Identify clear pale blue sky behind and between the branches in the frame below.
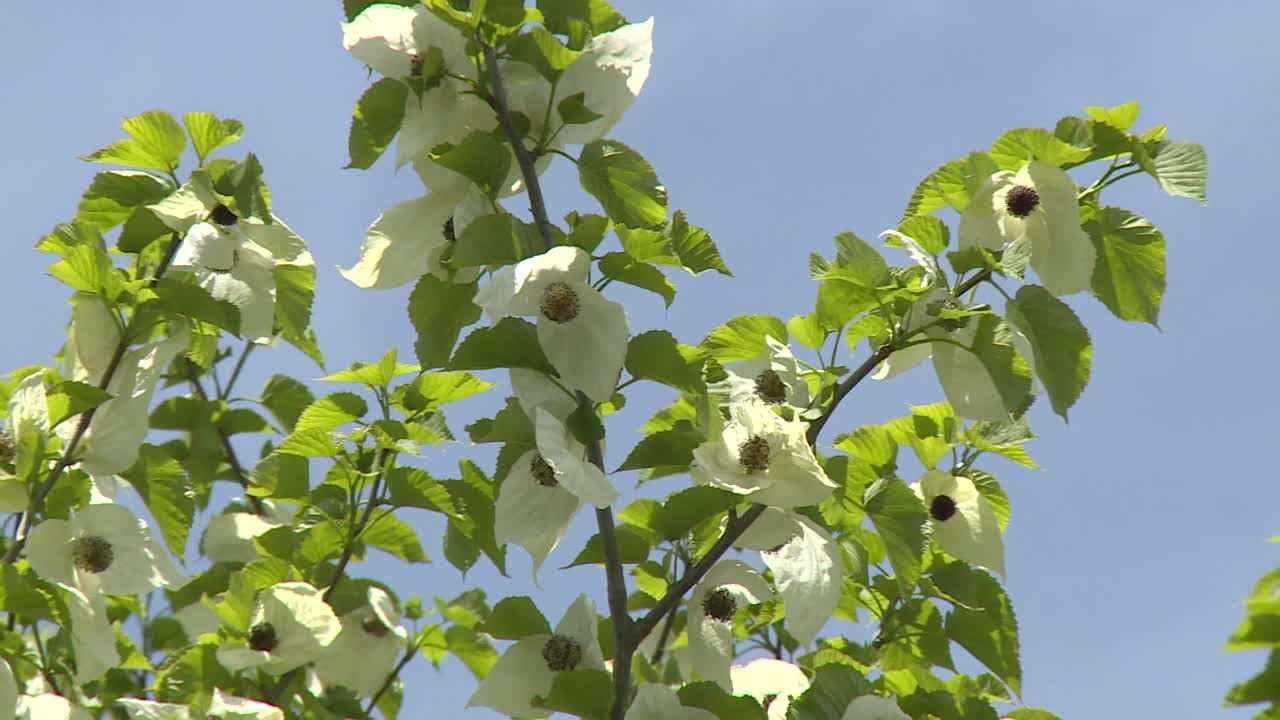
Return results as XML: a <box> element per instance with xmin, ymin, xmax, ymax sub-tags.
<box><xmin>0</xmin><ymin>0</ymin><xmax>1280</xmax><ymax>720</ymax></box>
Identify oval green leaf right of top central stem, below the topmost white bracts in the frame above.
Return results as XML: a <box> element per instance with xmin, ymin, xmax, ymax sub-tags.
<box><xmin>577</xmin><ymin>140</ymin><xmax>667</xmax><ymax>228</ymax></box>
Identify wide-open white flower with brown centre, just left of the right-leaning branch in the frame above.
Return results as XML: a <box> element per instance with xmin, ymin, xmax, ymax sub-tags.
<box><xmin>690</xmin><ymin>397</ymin><xmax>836</xmax><ymax>507</ymax></box>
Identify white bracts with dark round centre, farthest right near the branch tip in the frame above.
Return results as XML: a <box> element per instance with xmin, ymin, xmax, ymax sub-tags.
<box><xmin>960</xmin><ymin>160</ymin><xmax>1096</xmax><ymax>295</ymax></box>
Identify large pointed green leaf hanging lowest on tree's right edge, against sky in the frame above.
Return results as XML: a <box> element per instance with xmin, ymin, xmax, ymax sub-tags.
<box><xmin>929</xmin><ymin>561</ymin><xmax>1023</xmax><ymax>693</ymax></box>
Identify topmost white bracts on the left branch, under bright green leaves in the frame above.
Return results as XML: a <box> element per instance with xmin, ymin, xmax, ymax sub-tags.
<box><xmin>148</xmin><ymin>174</ymin><xmax>315</xmax><ymax>343</ymax></box>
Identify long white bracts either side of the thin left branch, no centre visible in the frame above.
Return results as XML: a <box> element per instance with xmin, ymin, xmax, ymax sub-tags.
<box><xmin>56</xmin><ymin>293</ymin><xmax>188</xmax><ymax>478</ymax></box>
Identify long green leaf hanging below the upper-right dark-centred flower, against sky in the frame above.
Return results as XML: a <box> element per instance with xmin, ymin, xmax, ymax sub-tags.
<box><xmin>1005</xmin><ymin>284</ymin><xmax>1093</xmax><ymax>420</ymax></box>
